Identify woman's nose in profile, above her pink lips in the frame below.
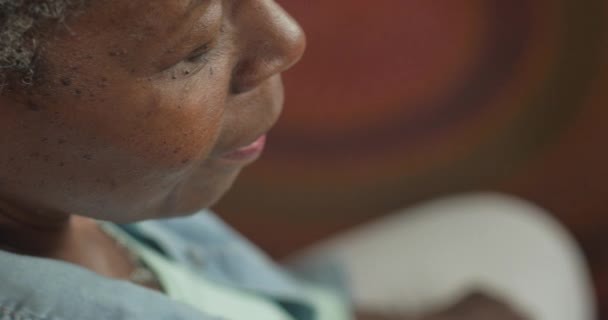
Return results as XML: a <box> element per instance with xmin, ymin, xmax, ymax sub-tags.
<box><xmin>232</xmin><ymin>0</ymin><xmax>306</xmax><ymax>94</ymax></box>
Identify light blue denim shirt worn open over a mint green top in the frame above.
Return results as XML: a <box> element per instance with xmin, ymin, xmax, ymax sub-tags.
<box><xmin>0</xmin><ymin>211</ymin><xmax>350</xmax><ymax>320</ymax></box>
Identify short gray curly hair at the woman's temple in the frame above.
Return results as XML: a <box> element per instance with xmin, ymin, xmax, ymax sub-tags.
<box><xmin>0</xmin><ymin>0</ymin><xmax>85</xmax><ymax>86</ymax></box>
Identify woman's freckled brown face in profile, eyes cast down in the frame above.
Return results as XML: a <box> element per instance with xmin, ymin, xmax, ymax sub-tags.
<box><xmin>0</xmin><ymin>0</ymin><xmax>305</xmax><ymax>222</ymax></box>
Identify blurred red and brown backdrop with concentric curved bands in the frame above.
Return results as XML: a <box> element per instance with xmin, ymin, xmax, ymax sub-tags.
<box><xmin>216</xmin><ymin>0</ymin><xmax>608</xmax><ymax>319</ymax></box>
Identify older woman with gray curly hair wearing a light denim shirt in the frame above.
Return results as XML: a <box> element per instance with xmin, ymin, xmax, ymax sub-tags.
<box><xmin>0</xmin><ymin>0</ymin><xmax>596</xmax><ymax>320</ymax></box>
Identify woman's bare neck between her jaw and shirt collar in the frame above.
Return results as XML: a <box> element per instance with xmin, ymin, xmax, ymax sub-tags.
<box><xmin>0</xmin><ymin>200</ymin><xmax>142</xmax><ymax>279</ymax></box>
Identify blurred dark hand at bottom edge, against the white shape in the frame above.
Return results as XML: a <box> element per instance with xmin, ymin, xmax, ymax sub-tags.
<box><xmin>357</xmin><ymin>293</ymin><xmax>532</xmax><ymax>320</ymax></box>
